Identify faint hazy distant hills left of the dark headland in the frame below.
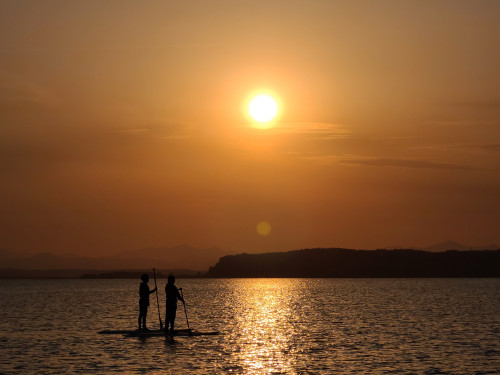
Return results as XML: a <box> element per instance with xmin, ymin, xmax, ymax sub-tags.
<box><xmin>0</xmin><ymin>245</ymin><xmax>234</xmax><ymax>271</ymax></box>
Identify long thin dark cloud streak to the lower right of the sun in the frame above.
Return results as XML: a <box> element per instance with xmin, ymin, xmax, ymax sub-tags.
<box><xmin>306</xmin><ymin>155</ymin><xmax>485</xmax><ymax>171</ymax></box>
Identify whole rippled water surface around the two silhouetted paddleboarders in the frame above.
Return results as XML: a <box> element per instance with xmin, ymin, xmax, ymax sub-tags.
<box><xmin>0</xmin><ymin>279</ymin><xmax>500</xmax><ymax>374</ymax></box>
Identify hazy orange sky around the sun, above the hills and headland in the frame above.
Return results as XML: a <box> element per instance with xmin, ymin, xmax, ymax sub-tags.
<box><xmin>0</xmin><ymin>0</ymin><xmax>500</xmax><ymax>254</ymax></box>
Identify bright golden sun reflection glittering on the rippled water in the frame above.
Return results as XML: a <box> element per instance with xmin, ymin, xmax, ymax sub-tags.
<box><xmin>228</xmin><ymin>279</ymin><xmax>308</xmax><ymax>373</ymax></box>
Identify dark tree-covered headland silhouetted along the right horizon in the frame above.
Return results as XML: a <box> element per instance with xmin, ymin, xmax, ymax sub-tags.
<box><xmin>207</xmin><ymin>249</ymin><xmax>500</xmax><ymax>277</ymax></box>
